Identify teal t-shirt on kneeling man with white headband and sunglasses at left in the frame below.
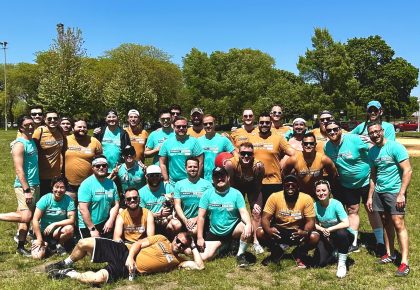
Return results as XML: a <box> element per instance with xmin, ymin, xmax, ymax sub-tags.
<box><xmin>77</xmin><ymin>175</ymin><xmax>120</xmax><ymax>228</ymax></box>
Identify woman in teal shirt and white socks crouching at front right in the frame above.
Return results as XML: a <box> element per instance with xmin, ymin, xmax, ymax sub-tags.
<box><xmin>314</xmin><ymin>180</ymin><xmax>354</xmax><ymax>278</ymax></box>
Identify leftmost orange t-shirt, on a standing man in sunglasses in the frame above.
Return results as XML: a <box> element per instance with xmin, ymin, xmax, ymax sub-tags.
<box><xmin>32</xmin><ymin>126</ymin><xmax>64</xmax><ymax>179</ymax></box>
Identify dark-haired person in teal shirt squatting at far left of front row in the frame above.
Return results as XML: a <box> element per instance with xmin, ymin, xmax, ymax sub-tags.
<box><xmin>32</xmin><ymin>177</ymin><xmax>76</xmax><ymax>259</ymax></box>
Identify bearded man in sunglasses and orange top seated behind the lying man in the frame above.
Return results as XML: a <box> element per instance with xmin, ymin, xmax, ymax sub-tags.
<box><xmin>113</xmin><ymin>188</ymin><xmax>155</xmax><ymax>244</ymax></box>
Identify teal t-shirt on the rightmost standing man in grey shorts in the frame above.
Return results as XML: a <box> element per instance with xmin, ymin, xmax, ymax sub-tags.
<box><xmin>368</xmin><ymin>140</ymin><xmax>408</xmax><ymax>194</ymax></box>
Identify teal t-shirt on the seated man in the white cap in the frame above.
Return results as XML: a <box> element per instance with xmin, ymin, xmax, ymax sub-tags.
<box><xmin>139</xmin><ymin>182</ymin><xmax>173</xmax><ymax>213</ymax></box>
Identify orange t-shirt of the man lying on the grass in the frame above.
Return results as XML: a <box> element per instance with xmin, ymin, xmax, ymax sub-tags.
<box><xmin>136</xmin><ymin>235</ymin><xmax>183</xmax><ymax>273</ymax></box>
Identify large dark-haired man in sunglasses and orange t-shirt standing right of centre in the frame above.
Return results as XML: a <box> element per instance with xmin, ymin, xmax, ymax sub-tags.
<box><xmin>249</xmin><ymin>114</ymin><xmax>295</xmax><ymax>206</ymax></box>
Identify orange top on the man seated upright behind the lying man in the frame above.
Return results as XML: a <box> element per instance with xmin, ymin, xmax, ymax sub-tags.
<box><xmin>120</xmin><ymin>208</ymin><xmax>149</xmax><ymax>243</ymax></box>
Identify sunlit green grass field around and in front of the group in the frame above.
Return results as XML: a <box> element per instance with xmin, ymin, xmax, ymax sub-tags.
<box><xmin>0</xmin><ymin>131</ymin><xmax>420</xmax><ymax>290</ymax></box>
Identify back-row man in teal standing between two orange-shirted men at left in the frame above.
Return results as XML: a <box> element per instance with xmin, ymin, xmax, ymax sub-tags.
<box><xmin>93</xmin><ymin>110</ymin><xmax>131</xmax><ymax>173</ymax></box>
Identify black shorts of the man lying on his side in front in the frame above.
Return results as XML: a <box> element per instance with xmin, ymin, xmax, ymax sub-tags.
<box><xmin>92</xmin><ymin>238</ymin><xmax>129</xmax><ymax>283</ymax></box>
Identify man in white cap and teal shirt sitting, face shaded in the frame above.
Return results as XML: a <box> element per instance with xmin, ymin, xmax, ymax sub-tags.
<box><xmin>140</xmin><ymin>165</ymin><xmax>182</xmax><ymax>236</ymax></box>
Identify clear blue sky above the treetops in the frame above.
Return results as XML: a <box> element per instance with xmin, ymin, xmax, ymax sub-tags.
<box><xmin>0</xmin><ymin>0</ymin><xmax>420</xmax><ymax>96</ymax></box>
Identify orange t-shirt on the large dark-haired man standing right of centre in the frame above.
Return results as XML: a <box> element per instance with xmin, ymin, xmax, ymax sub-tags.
<box><xmin>249</xmin><ymin>133</ymin><xmax>290</xmax><ymax>184</ymax></box>
